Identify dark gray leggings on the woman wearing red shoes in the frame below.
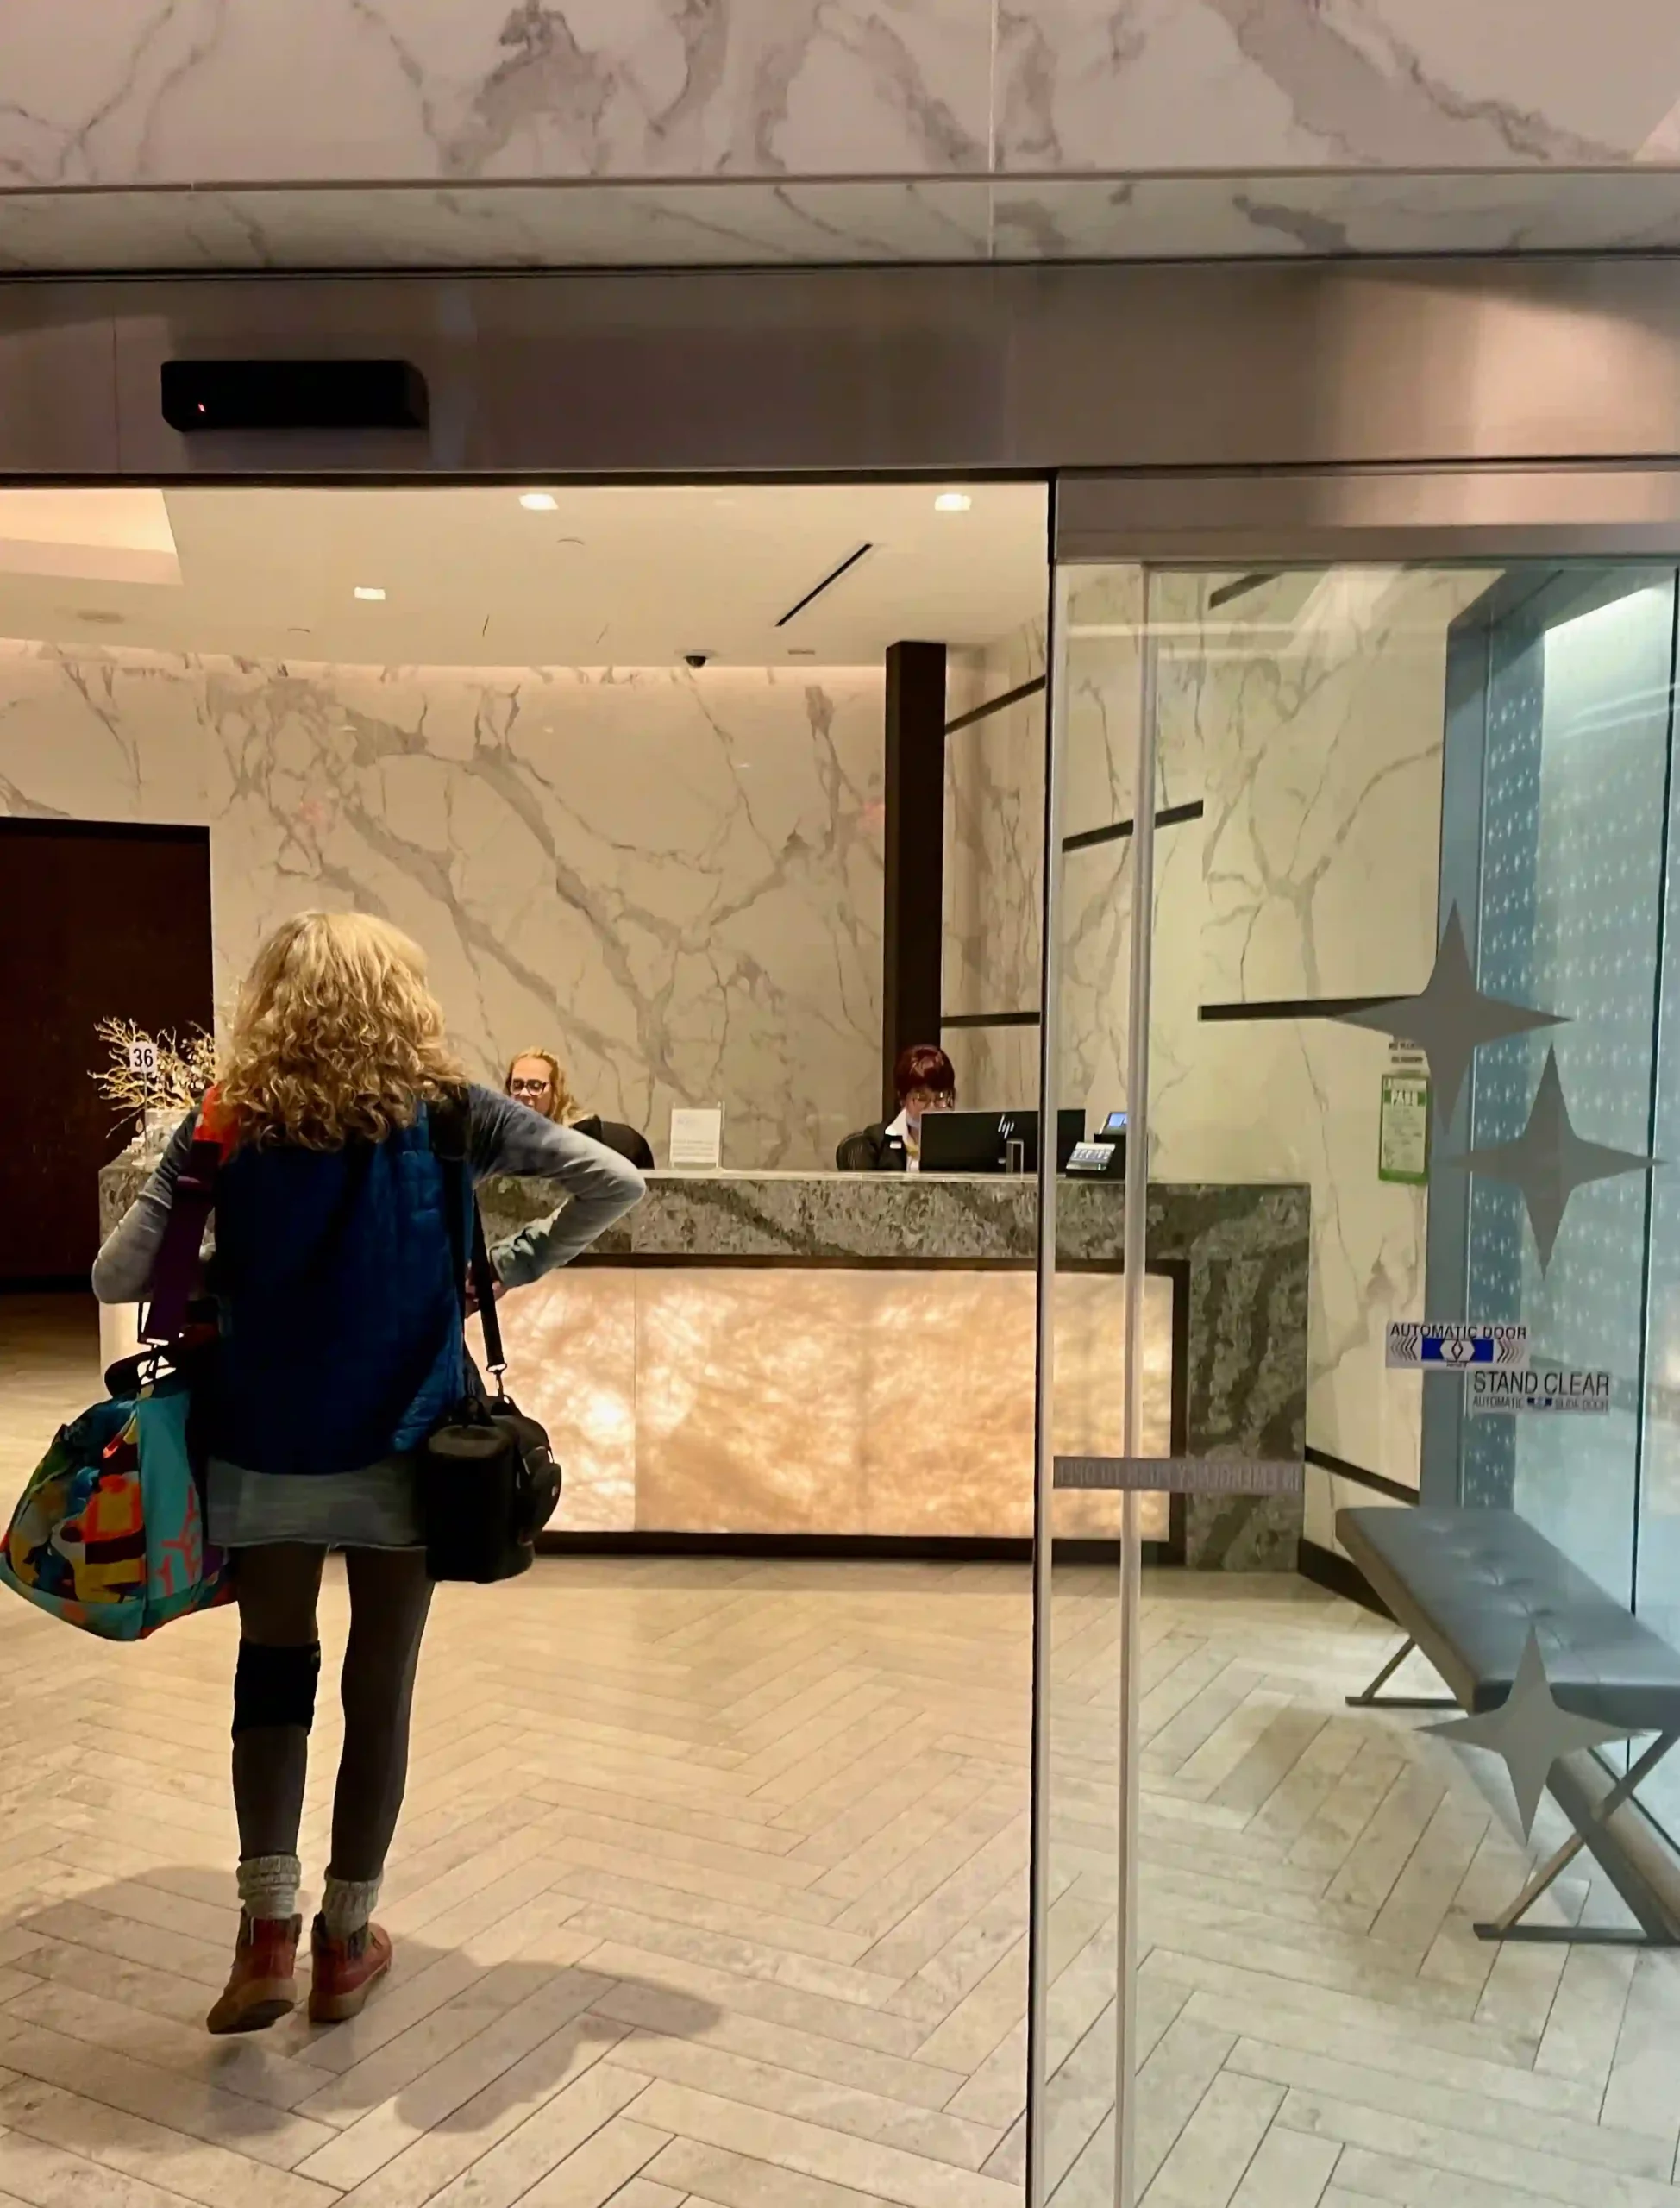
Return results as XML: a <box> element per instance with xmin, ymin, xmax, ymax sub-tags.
<box><xmin>234</xmin><ymin>1541</ymin><xmax>433</xmax><ymax>1879</ymax></box>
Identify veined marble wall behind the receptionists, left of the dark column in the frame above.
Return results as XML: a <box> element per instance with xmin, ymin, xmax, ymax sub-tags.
<box><xmin>0</xmin><ymin>645</ymin><xmax>881</xmax><ymax>1166</ymax></box>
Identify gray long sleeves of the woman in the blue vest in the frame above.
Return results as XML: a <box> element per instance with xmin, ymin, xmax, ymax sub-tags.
<box><xmin>93</xmin><ymin>1084</ymin><xmax>647</xmax><ymax>1302</ymax></box>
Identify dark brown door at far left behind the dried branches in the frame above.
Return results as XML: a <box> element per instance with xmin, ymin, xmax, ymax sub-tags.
<box><xmin>0</xmin><ymin>819</ymin><xmax>212</xmax><ymax>1289</ymax></box>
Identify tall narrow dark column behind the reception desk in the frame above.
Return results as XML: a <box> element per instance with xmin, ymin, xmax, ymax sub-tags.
<box><xmin>881</xmin><ymin>643</ymin><xmax>945</xmax><ymax>1117</ymax></box>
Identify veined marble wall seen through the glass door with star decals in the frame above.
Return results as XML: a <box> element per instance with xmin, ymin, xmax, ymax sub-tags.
<box><xmin>1155</xmin><ymin>569</ymin><xmax>1488</xmax><ymax>1486</ymax></box>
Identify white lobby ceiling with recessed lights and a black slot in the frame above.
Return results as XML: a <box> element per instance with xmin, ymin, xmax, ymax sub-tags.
<box><xmin>0</xmin><ymin>484</ymin><xmax>1046</xmax><ymax>667</ymax></box>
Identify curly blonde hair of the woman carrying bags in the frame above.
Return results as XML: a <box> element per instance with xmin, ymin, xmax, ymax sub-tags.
<box><xmin>218</xmin><ymin>912</ymin><xmax>466</xmax><ymax>1151</ymax></box>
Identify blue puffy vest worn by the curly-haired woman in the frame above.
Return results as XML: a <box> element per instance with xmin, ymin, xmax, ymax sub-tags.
<box><xmin>204</xmin><ymin>1111</ymin><xmax>468</xmax><ymax>1473</ymax></box>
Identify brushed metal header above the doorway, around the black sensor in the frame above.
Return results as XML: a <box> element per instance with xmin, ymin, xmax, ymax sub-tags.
<box><xmin>13</xmin><ymin>254</ymin><xmax>1680</xmax><ymax>483</ymax></box>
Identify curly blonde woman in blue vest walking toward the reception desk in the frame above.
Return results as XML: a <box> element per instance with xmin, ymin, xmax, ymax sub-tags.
<box><xmin>93</xmin><ymin>912</ymin><xmax>643</xmax><ymax>2031</ymax></box>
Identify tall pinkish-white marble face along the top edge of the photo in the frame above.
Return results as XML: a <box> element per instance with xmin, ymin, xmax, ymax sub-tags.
<box><xmin>0</xmin><ymin>0</ymin><xmax>1680</xmax><ymax>188</ymax></box>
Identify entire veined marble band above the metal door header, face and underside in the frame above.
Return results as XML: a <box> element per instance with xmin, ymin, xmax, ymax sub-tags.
<box><xmin>0</xmin><ymin>0</ymin><xmax>1680</xmax><ymax>242</ymax></box>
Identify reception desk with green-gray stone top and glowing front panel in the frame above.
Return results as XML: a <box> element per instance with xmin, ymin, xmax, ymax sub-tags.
<box><xmin>99</xmin><ymin>1152</ymin><xmax>1309</xmax><ymax>1570</ymax></box>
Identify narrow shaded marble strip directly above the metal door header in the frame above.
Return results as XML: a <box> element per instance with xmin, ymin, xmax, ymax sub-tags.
<box><xmin>16</xmin><ymin>168</ymin><xmax>1680</xmax><ymax>273</ymax></box>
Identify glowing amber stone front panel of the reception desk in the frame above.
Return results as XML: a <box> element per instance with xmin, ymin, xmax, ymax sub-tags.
<box><xmin>501</xmin><ymin>1261</ymin><xmax>1175</xmax><ymax>1541</ymax></box>
